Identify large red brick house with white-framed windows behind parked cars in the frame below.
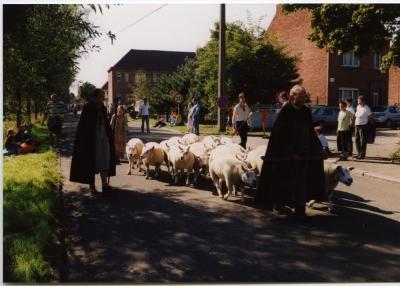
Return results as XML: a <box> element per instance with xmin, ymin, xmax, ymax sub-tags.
<box><xmin>266</xmin><ymin>5</ymin><xmax>394</xmax><ymax>106</ymax></box>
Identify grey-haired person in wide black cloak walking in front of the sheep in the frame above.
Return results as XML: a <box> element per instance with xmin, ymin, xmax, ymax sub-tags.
<box><xmin>255</xmin><ymin>85</ymin><xmax>325</xmax><ymax>217</ymax></box>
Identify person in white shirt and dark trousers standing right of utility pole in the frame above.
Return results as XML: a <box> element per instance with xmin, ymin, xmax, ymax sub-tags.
<box><xmin>232</xmin><ymin>92</ymin><xmax>251</xmax><ymax>148</ymax></box>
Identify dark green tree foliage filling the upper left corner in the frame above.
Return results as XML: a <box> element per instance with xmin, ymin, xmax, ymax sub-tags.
<box><xmin>3</xmin><ymin>4</ymin><xmax>100</xmax><ymax>125</ymax></box>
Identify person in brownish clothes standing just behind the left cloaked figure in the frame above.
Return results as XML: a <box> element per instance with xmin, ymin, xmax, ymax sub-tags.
<box><xmin>111</xmin><ymin>105</ymin><xmax>128</xmax><ymax>162</ymax></box>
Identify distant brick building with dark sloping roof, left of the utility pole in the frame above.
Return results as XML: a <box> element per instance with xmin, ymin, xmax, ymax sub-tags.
<box><xmin>103</xmin><ymin>50</ymin><xmax>195</xmax><ymax>107</ymax></box>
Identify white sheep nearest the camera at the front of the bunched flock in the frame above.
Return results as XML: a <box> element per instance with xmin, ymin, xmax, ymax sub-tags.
<box><xmin>209</xmin><ymin>154</ymin><xmax>256</xmax><ymax>200</ymax></box>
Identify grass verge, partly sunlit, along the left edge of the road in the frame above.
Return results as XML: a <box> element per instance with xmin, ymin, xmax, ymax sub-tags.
<box><xmin>3</xmin><ymin>152</ymin><xmax>61</xmax><ymax>282</ymax></box>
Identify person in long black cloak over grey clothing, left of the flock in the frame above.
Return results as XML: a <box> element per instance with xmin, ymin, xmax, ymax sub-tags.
<box><xmin>70</xmin><ymin>89</ymin><xmax>116</xmax><ymax>193</ymax></box>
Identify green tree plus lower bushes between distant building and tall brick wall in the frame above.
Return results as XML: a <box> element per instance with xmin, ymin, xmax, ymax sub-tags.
<box><xmin>153</xmin><ymin>22</ymin><xmax>298</xmax><ymax>119</ymax></box>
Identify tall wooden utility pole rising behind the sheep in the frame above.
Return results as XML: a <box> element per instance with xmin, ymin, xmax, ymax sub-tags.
<box><xmin>218</xmin><ymin>4</ymin><xmax>226</xmax><ymax>131</ymax></box>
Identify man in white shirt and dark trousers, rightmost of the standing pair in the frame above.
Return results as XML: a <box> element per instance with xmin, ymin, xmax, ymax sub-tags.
<box><xmin>353</xmin><ymin>95</ymin><xmax>372</xmax><ymax>159</ymax></box>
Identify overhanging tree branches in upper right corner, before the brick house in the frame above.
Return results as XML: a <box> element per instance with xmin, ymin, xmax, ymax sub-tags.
<box><xmin>282</xmin><ymin>4</ymin><xmax>400</xmax><ymax>71</ymax></box>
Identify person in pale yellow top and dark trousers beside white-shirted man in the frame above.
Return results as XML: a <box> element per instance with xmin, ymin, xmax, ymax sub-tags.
<box><xmin>337</xmin><ymin>101</ymin><xmax>353</xmax><ymax>160</ymax></box>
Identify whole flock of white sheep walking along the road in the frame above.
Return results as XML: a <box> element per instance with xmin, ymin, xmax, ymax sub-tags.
<box><xmin>126</xmin><ymin>133</ymin><xmax>353</xmax><ymax>207</ymax></box>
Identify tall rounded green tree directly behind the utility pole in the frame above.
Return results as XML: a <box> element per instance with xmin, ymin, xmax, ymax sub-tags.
<box><xmin>195</xmin><ymin>22</ymin><xmax>298</xmax><ymax>119</ymax></box>
